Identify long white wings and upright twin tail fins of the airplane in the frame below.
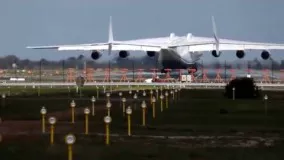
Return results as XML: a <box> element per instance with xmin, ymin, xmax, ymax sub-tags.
<box><xmin>27</xmin><ymin>16</ymin><xmax>284</xmax><ymax>52</ymax></box>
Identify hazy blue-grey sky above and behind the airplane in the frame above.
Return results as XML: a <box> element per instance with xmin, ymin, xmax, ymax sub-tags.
<box><xmin>0</xmin><ymin>0</ymin><xmax>284</xmax><ymax>60</ymax></box>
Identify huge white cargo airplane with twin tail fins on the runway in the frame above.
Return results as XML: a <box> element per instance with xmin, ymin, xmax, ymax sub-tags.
<box><xmin>27</xmin><ymin>16</ymin><xmax>284</xmax><ymax>72</ymax></box>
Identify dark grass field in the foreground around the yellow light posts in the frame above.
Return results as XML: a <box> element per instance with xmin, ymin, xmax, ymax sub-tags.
<box><xmin>0</xmin><ymin>88</ymin><xmax>284</xmax><ymax>160</ymax></box>
